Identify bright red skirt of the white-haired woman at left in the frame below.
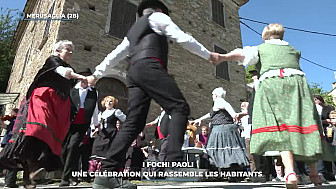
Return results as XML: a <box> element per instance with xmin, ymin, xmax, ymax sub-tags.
<box><xmin>26</xmin><ymin>87</ymin><xmax>70</xmax><ymax>156</ymax></box>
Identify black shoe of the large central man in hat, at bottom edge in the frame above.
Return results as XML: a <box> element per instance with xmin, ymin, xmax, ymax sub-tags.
<box><xmin>93</xmin><ymin>177</ymin><xmax>137</xmax><ymax>189</ymax></box>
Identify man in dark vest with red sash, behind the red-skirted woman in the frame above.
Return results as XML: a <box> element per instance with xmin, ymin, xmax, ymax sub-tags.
<box><xmin>60</xmin><ymin>69</ymin><xmax>99</xmax><ymax>186</ymax></box>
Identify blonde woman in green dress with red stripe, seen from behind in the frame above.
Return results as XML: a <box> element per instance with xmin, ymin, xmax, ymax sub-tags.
<box><xmin>215</xmin><ymin>24</ymin><xmax>325</xmax><ymax>188</ymax></box>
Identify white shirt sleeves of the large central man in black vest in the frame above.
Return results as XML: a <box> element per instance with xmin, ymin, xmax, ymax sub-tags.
<box><xmin>93</xmin><ymin>12</ymin><xmax>210</xmax><ymax>79</ymax></box>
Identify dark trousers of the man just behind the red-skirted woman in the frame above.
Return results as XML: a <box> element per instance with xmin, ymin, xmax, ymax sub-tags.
<box><xmin>62</xmin><ymin>124</ymin><xmax>88</xmax><ymax>181</ymax></box>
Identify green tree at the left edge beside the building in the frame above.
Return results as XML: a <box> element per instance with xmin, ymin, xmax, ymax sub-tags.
<box><xmin>0</xmin><ymin>8</ymin><xmax>18</xmax><ymax>92</ymax></box>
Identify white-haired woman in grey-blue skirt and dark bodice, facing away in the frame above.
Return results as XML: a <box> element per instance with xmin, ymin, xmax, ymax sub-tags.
<box><xmin>191</xmin><ymin>87</ymin><xmax>249</xmax><ymax>169</ymax></box>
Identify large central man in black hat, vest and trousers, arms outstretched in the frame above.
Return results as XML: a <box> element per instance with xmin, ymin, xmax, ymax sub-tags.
<box><xmin>88</xmin><ymin>0</ymin><xmax>219</xmax><ymax>188</ymax></box>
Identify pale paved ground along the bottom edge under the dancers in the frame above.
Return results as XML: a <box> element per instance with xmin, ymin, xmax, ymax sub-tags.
<box><xmin>0</xmin><ymin>178</ymin><xmax>336</xmax><ymax>189</ymax></box>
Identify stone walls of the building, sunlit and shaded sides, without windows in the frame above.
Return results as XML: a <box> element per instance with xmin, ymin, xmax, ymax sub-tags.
<box><xmin>8</xmin><ymin>0</ymin><xmax>246</xmax><ymax>120</ymax></box>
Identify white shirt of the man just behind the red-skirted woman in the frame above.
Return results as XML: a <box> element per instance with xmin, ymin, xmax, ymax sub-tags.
<box><xmin>74</xmin><ymin>82</ymin><xmax>99</xmax><ymax>130</ymax></box>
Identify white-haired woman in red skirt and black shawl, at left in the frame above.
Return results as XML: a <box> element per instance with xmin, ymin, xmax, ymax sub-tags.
<box><xmin>16</xmin><ymin>40</ymin><xmax>86</xmax><ymax>185</ymax></box>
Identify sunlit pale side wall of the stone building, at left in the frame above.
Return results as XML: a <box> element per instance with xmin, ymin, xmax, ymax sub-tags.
<box><xmin>7</xmin><ymin>0</ymin><xmax>64</xmax><ymax>112</ymax></box>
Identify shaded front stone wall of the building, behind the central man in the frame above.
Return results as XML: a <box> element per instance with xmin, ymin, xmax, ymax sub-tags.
<box><xmin>59</xmin><ymin>0</ymin><xmax>246</xmax><ymax>120</ymax></box>
